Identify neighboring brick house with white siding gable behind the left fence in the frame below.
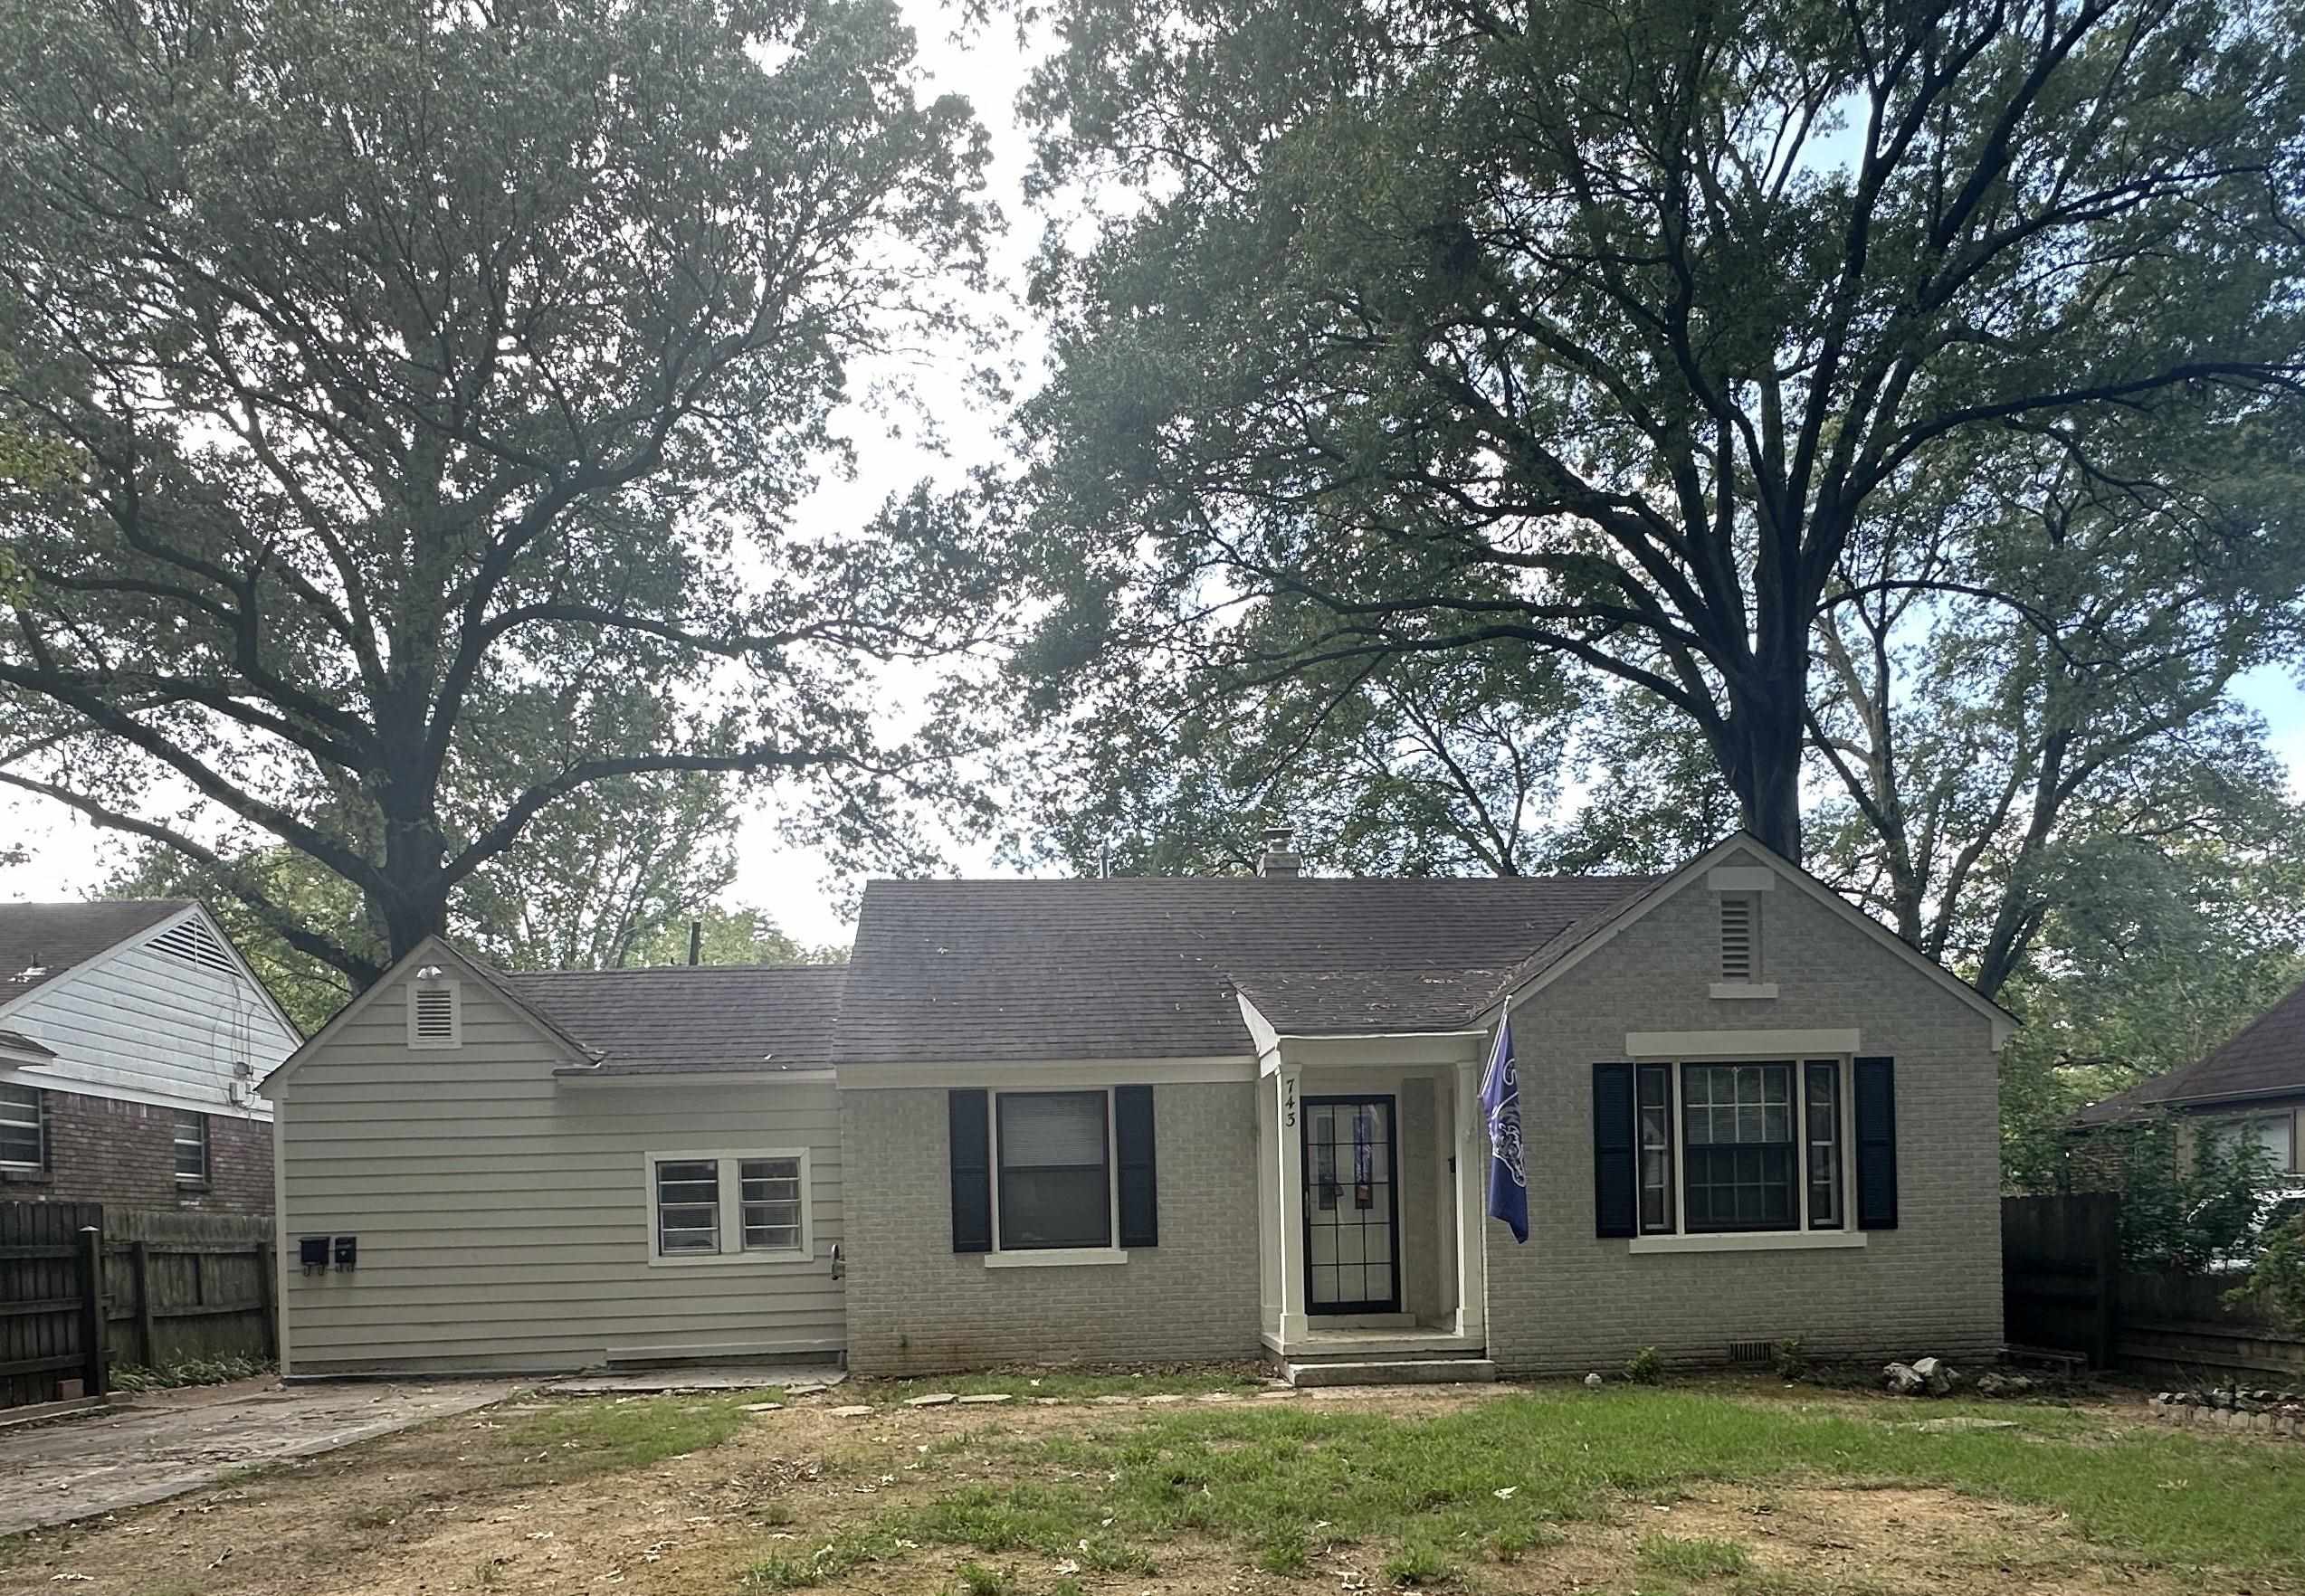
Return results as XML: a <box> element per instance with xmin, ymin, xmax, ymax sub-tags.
<box><xmin>0</xmin><ymin>898</ymin><xmax>298</xmax><ymax>1213</ymax></box>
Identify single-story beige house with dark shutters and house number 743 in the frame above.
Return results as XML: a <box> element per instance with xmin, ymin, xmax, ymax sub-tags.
<box><xmin>267</xmin><ymin>836</ymin><xmax>2013</xmax><ymax>1375</ymax></box>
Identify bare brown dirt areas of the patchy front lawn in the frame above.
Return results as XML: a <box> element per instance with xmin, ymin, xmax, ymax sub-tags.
<box><xmin>0</xmin><ymin>1389</ymin><xmax>2240</xmax><ymax>1596</ymax></box>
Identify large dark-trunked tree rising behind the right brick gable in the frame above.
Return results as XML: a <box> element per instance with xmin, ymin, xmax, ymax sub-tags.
<box><xmin>1024</xmin><ymin>0</ymin><xmax>2305</xmax><ymax>857</ymax></box>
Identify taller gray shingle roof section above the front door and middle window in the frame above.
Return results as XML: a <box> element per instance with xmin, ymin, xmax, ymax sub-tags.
<box><xmin>834</xmin><ymin>875</ymin><xmax>1653</xmax><ymax>1064</ymax></box>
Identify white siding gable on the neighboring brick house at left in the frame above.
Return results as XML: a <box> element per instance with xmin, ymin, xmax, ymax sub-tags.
<box><xmin>0</xmin><ymin>921</ymin><xmax>298</xmax><ymax>1119</ymax></box>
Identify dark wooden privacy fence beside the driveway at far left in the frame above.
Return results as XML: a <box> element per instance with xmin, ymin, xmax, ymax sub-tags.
<box><xmin>0</xmin><ymin>1202</ymin><xmax>279</xmax><ymax>1407</ymax></box>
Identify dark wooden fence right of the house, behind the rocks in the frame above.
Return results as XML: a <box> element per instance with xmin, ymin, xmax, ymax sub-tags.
<box><xmin>2001</xmin><ymin>1193</ymin><xmax>2305</xmax><ymax>1384</ymax></box>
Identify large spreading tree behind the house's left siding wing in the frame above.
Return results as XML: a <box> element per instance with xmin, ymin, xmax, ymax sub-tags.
<box><xmin>0</xmin><ymin>0</ymin><xmax>994</xmax><ymax>985</ymax></box>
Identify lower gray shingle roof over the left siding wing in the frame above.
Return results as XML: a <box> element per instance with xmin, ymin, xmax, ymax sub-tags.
<box><xmin>509</xmin><ymin>965</ymin><xmax>848</xmax><ymax>1076</ymax></box>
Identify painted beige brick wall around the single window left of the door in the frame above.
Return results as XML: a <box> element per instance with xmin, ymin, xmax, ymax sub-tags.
<box><xmin>842</xmin><ymin>1080</ymin><xmax>1259</xmax><ymax>1375</ymax></box>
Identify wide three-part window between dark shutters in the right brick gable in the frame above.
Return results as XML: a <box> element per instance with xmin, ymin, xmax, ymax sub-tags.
<box><xmin>1634</xmin><ymin>1057</ymin><xmax>1853</xmax><ymax>1237</ymax></box>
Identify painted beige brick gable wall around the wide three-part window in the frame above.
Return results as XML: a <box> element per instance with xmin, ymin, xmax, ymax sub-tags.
<box><xmin>1484</xmin><ymin>851</ymin><xmax>2001</xmax><ymax>1373</ymax></box>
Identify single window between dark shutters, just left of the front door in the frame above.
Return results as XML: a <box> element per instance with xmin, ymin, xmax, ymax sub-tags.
<box><xmin>994</xmin><ymin>1087</ymin><xmax>1120</xmax><ymax>1253</ymax></box>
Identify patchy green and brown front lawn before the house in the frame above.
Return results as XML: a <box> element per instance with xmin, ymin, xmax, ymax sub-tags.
<box><xmin>0</xmin><ymin>1371</ymin><xmax>2305</xmax><ymax>1596</ymax></box>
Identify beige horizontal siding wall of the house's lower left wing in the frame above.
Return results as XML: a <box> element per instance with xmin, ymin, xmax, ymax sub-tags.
<box><xmin>277</xmin><ymin>979</ymin><xmax>843</xmax><ymax>1375</ymax></box>
